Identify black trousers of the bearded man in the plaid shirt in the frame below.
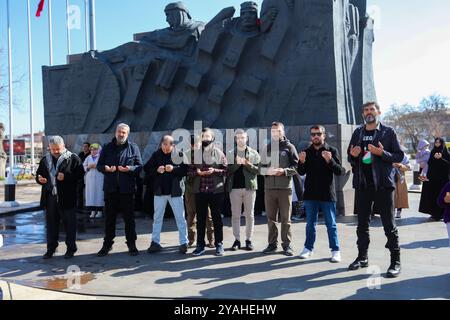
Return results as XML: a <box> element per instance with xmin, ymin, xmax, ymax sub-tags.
<box><xmin>195</xmin><ymin>193</ymin><xmax>225</xmax><ymax>247</ymax></box>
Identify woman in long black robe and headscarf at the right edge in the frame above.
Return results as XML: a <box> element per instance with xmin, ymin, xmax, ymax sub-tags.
<box><xmin>419</xmin><ymin>138</ymin><xmax>450</xmax><ymax>221</ymax></box>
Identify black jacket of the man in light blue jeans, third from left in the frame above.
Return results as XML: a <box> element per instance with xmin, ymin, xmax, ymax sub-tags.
<box><xmin>144</xmin><ymin>149</ymin><xmax>189</xmax><ymax>197</ymax></box>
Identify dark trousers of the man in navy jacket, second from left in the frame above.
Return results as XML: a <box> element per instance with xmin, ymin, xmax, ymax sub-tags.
<box><xmin>104</xmin><ymin>192</ymin><xmax>137</xmax><ymax>247</ymax></box>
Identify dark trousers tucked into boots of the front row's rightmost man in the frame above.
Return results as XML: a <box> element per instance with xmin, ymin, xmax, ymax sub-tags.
<box><xmin>355</xmin><ymin>189</ymin><xmax>400</xmax><ymax>254</ymax></box>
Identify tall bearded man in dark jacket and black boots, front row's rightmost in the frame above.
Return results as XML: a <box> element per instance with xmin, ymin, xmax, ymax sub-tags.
<box><xmin>347</xmin><ymin>102</ymin><xmax>404</xmax><ymax>278</ymax></box>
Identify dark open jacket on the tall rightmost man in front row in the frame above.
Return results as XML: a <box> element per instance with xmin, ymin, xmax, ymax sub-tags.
<box><xmin>347</xmin><ymin>123</ymin><xmax>404</xmax><ymax>190</ymax></box>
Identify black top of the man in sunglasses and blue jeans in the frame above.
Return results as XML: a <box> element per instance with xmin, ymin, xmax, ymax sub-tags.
<box><xmin>298</xmin><ymin>143</ymin><xmax>345</xmax><ymax>202</ymax></box>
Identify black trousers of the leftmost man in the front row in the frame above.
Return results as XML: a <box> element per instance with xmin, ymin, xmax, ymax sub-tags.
<box><xmin>45</xmin><ymin>194</ymin><xmax>77</xmax><ymax>252</ymax></box>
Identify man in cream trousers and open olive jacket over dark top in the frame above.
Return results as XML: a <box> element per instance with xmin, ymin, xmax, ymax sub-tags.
<box><xmin>227</xmin><ymin>129</ymin><xmax>260</xmax><ymax>251</ymax></box>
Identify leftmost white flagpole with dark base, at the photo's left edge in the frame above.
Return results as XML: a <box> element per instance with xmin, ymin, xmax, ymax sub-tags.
<box><xmin>1</xmin><ymin>0</ymin><xmax>19</xmax><ymax>207</ymax></box>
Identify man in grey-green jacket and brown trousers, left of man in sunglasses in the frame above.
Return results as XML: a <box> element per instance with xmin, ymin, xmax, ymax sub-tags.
<box><xmin>260</xmin><ymin>122</ymin><xmax>298</xmax><ymax>256</ymax></box>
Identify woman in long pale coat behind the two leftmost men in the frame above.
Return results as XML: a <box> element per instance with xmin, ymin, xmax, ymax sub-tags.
<box><xmin>83</xmin><ymin>143</ymin><xmax>105</xmax><ymax>219</ymax></box>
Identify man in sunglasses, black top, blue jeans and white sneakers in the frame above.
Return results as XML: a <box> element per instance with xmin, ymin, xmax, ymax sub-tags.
<box><xmin>297</xmin><ymin>125</ymin><xmax>345</xmax><ymax>263</ymax></box>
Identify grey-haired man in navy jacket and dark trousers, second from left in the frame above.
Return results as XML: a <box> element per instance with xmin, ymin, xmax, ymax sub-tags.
<box><xmin>97</xmin><ymin>123</ymin><xmax>142</xmax><ymax>257</ymax></box>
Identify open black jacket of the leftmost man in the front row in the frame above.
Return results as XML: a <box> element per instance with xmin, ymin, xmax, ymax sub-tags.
<box><xmin>36</xmin><ymin>154</ymin><xmax>84</xmax><ymax>210</ymax></box>
